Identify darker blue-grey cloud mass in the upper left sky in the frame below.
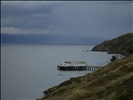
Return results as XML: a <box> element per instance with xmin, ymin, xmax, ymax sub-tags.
<box><xmin>2</xmin><ymin>2</ymin><xmax>60</xmax><ymax>29</ymax></box>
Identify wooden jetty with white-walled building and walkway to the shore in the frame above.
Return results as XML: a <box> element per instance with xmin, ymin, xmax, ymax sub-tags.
<box><xmin>57</xmin><ymin>61</ymin><xmax>101</xmax><ymax>71</ymax></box>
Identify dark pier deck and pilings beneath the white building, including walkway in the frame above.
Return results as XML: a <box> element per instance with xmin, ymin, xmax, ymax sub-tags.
<box><xmin>57</xmin><ymin>66</ymin><xmax>101</xmax><ymax>71</ymax></box>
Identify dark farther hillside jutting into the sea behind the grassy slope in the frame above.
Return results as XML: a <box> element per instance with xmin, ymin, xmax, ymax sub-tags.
<box><xmin>92</xmin><ymin>33</ymin><xmax>133</xmax><ymax>54</ymax></box>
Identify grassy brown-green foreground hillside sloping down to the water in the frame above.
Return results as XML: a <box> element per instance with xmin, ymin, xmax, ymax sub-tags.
<box><xmin>37</xmin><ymin>54</ymin><xmax>133</xmax><ymax>100</ymax></box>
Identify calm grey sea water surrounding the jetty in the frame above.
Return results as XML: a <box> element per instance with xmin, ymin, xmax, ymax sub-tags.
<box><xmin>1</xmin><ymin>45</ymin><xmax>112</xmax><ymax>100</ymax></box>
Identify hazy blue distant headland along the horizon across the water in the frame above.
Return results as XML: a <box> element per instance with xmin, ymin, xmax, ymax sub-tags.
<box><xmin>1</xmin><ymin>33</ymin><xmax>104</xmax><ymax>45</ymax></box>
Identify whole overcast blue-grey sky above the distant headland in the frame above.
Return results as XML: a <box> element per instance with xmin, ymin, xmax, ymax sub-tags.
<box><xmin>1</xmin><ymin>1</ymin><xmax>133</xmax><ymax>38</ymax></box>
